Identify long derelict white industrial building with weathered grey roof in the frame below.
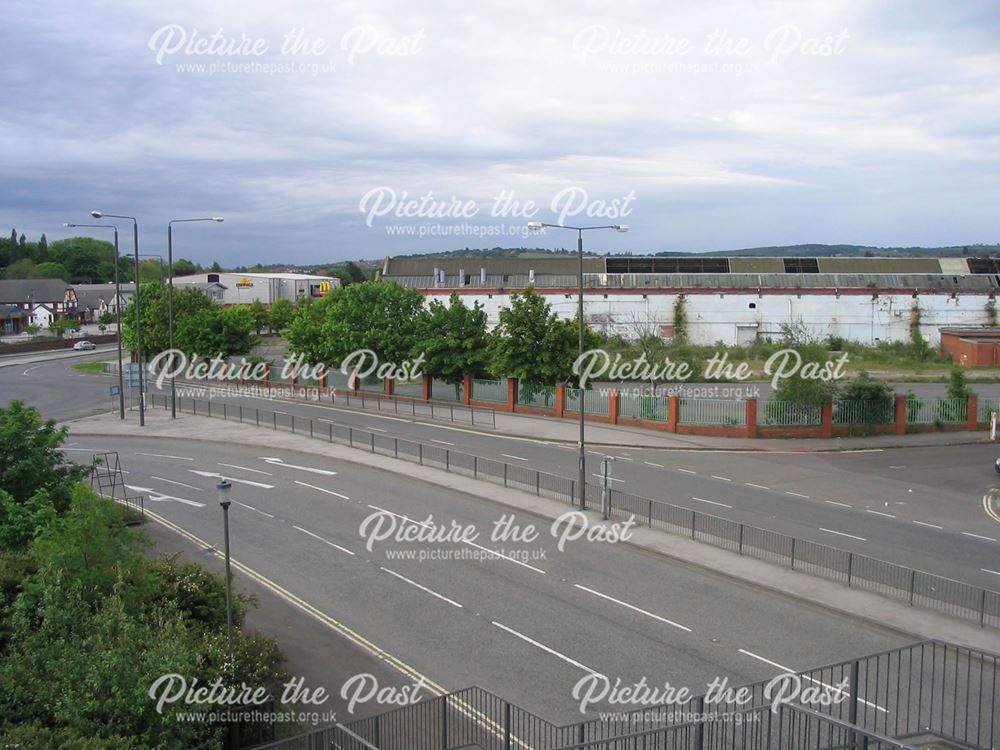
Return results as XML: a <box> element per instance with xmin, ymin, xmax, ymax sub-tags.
<box><xmin>382</xmin><ymin>255</ymin><xmax>1000</xmax><ymax>346</ymax></box>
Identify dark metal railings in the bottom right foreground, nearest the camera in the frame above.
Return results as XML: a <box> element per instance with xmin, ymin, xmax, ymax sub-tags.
<box><xmin>252</xmin><ymin>641</ymin><xmax>1000</xmax><ymax>750</ymax></box>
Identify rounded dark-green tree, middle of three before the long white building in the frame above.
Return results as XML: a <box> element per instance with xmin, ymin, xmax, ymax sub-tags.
<box><xmin>411</xmin><ymin>292</ymin><xmax>489</xmax><ymax>383</ymax></box>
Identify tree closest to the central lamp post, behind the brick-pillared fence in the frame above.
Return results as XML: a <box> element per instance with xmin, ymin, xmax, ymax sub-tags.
<box><xmin>489</xmin><ymin>287</ymin><xmax>601</xmax><ymax>385</ymax></box>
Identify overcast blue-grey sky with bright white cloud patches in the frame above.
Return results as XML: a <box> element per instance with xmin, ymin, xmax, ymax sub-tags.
<box><xmin>0</xmin><ymin>0</ymin><xmax>1000</xmax><ymax>265</ymax></box>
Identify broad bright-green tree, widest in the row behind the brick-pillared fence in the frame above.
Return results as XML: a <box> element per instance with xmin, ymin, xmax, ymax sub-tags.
<box><xmin>284</xmin><ymin>281</ymin><xmax>424</xmax><ymax>365</ymax></box>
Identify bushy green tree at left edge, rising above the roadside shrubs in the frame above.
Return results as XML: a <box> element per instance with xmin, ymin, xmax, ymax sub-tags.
<box><xmin>0</xmin><ymin>401</ymin><xmax>89</xmax><ymax>511</ymax></box>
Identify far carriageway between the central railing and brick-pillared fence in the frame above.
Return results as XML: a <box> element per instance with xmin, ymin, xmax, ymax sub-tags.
<box><xmin>7</xmin><ymin>355</ymin><xmax>1000</xmax><ymax>588</ymax></box>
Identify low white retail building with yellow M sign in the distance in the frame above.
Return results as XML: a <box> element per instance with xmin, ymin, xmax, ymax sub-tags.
<box><xmin>174</xmin><ymin>271</ymin><xmax>340</xmax><ymax>305</ymax></box>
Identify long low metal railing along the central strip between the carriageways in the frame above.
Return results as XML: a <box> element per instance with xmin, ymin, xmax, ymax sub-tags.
<box><xmin>150</xmin><ymin>394</ymin><xmax>1000</xmax><ymax>627</ymax></box>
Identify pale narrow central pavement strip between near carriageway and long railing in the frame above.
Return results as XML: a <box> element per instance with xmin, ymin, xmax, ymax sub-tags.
<box><xmin>70</xmin><ymin>412</ymin><xmax>1000</xmax><ymax>664</ymax></box>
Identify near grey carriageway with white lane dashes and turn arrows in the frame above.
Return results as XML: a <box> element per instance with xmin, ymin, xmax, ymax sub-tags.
<box><xmin>67</xmin><ymin>436</ymin><xmax>907</xmax><ymax>721</ymax></box>
